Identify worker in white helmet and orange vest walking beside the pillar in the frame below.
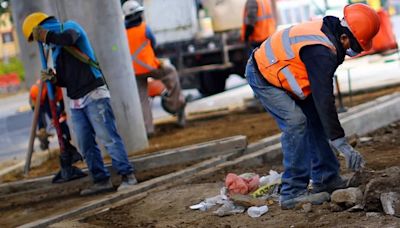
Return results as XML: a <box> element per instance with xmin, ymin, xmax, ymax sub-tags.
<box><xmin>122</xmin><ymin>0</ymin><xmax>186</xmax><ymax>135</ymax></box>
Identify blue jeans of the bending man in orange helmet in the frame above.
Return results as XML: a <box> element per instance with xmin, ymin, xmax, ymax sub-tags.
<box><xmin>245</xmin><ymin>58</ymin><xmax>339</xmax><ymax>201</ymax></box>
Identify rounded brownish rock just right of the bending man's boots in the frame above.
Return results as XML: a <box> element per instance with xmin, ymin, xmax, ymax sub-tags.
<box><xmin>331</xmin><ymin>188</ymin><xmax>363</xmax><ymax>208</ymax></box>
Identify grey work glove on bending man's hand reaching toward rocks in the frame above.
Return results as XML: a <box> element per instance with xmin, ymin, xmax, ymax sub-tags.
<box><xmin>331</xmin><ymin>137</ymin><xmax>365</xmax><ymax>171</ymax></box>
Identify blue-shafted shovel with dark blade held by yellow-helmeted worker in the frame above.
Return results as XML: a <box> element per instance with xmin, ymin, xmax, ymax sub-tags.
<box><xmin>38</xmin><ymin>42</ymin><xmax>86</xmax><ymax>183</ymax></box>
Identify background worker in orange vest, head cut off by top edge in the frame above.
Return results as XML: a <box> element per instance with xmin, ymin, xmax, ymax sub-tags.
<box><xmin>241</xmin><ymin>0</ymin><xmax>276</xmax><ymax>53</ymax></box>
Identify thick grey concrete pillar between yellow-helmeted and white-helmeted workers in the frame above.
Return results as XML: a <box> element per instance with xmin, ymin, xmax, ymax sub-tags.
<box><xmin>56</xmin><ymin>0</ymin><xmax>148</xmax><ymax>152</ymax></box>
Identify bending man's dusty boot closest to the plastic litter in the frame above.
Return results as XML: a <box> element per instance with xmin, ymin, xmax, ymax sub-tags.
<box><xmin>280</xmin><ymin>192</ymin><xmax>330</xmax><ymax>210</ymax></box>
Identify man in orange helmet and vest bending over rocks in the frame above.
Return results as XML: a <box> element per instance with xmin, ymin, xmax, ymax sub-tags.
<box><xmin>246</xmin><ymin>3</ymin><xmax>380</xmax><ymax>209</ymax></box>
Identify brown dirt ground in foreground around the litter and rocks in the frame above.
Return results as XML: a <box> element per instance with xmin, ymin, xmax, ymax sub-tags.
<box><xmin>82</xmin><ymin>122</ymin><xmax>400</xmax><ymax>228</ymax></box>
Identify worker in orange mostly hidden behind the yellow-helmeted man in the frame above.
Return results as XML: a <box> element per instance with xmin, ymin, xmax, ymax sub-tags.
<box><xmin>29</xmin><ymin>80</ymin><xmax>83</xmax><ymax>163</ymax></box>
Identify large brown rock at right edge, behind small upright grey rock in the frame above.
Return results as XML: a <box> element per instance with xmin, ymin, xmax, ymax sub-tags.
<box><xmin>363</xmin><ymin>166</ymin><xmax>400</xmax><ymax>211</ymax></box>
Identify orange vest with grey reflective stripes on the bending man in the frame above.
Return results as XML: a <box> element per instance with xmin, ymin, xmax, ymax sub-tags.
<box><xmin>254</xmin><ymin>20</ymin><xmax>336</xmax><ymax>100</ymax></box>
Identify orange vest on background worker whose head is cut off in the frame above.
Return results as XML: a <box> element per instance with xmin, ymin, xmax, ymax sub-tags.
<box><xmin>242</xmin><ymin>0</ymin><xmax>276</xmax><ymax>42</ymax></box>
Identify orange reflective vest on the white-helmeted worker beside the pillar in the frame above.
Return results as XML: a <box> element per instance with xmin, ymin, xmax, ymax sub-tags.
<box><xmin>126</xmin><ymin>22</ymin><xmax>160</xmax><ymax>75</ymax></box>
